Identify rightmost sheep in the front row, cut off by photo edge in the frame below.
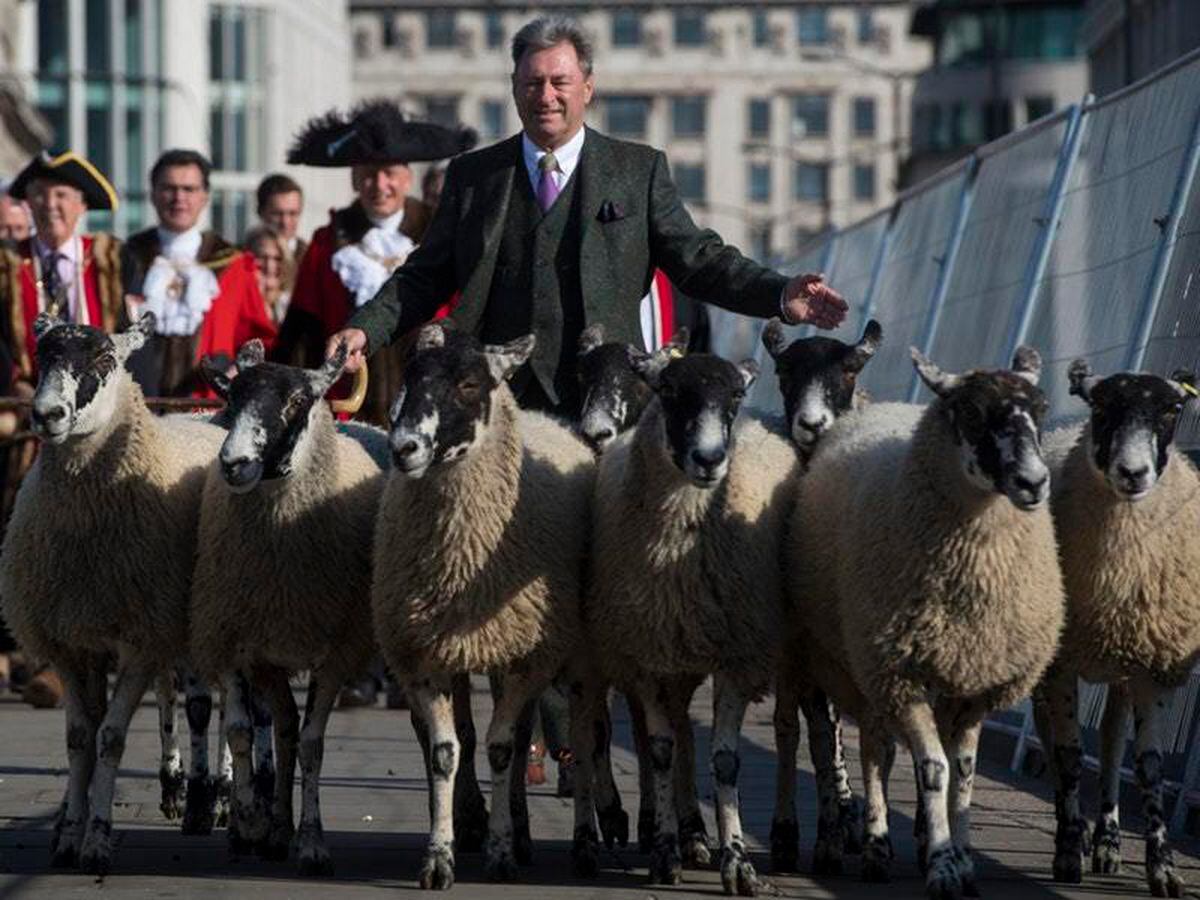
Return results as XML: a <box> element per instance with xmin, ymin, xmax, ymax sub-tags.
<box><xmin>1036</xmin><ymin>359</ymin><xmax>1200</xmax><ymax>896</ymax></box>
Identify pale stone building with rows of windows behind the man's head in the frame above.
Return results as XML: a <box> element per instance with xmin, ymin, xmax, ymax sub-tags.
<box><xmin>350</xmin><ymin>0</ymin><xmax>929</xmax><ymax>258</ymax></box>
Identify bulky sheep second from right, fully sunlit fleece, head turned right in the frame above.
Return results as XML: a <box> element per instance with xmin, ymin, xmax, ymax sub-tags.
<box><xmin>785</xmin><ymin>347</ymin><xmax>1063</xmax><ymax>898</ymax></box>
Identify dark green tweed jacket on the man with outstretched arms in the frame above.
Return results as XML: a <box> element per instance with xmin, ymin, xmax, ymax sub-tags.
<box><xmin>347</xmin><ymin>128</ymin><xmax>787</xmax><ymax>353</ymax></box>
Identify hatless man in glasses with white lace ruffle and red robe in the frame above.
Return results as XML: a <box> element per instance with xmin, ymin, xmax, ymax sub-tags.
<box><xmin>124</xmin><ymin>150</ymin><xmax>276</xmax><ymax>397</ymax></box>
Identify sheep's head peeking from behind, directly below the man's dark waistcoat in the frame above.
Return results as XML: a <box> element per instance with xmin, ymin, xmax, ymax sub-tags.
<box><xmin>576</xmin><ymin>325</ymin><xmax>688</xmax><ymax>454</ymax></box>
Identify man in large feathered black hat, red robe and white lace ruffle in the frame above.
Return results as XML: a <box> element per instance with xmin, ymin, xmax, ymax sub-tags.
<box><xmin>275</xmin><ymin>100</ymin><xmax>475</xmax><ymax>425</ymax></box>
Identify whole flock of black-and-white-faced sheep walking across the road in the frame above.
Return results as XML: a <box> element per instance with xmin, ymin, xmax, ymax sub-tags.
<box><xmin>0</xmin><ymin>317</ymin><xmax>1200</xmax><ymax>899</ymax></box>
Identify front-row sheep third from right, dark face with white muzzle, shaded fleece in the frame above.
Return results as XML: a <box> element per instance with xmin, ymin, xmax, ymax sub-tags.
<box><xmin>584</xmin><ymin>349</ymin><xmax>799</xmax><ymax>895</ymax></box>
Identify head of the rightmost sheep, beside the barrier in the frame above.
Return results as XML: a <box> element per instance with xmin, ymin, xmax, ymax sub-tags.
<box><xmin>1067</xmin><ymin>359</ymin><xmax>1196</xmax><ymax>500</ymax></box>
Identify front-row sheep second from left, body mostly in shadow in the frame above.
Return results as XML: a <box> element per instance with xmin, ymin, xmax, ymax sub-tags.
<box><xmin>191</xmin><ymin>341</ymin><xmax>385</xmax><ymax>875</ymax></box>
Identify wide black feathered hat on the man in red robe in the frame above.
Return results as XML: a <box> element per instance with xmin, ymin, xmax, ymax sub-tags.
<box><xmin>288</xmin><ymin>100</ymin><xmax>478</xmax><ymax>167</ymax></box>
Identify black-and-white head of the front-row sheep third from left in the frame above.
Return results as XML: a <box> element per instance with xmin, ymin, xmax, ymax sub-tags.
<box><xmin>388</xmin><ymin>324</ymin><xmax>534</xmax><ymax>478</ymax></box>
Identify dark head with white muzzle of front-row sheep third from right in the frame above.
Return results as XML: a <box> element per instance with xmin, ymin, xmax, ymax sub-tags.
<box><xmin>634</xmin><ymin>347</ymin><xmax>758</xmax><ymax>487</ymax></box>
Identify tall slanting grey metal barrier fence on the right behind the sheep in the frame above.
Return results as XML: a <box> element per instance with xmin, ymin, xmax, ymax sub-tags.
<box><xmin>712</xmin><ymin>50</ymin><xmax>1200</xmax><ymax>829</ymax></box>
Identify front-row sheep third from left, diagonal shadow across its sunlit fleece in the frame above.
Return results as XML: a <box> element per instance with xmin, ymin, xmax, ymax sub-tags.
<box><xmin>371</xmin><ymin>324</ymin><xmax>595</xmax><ymax>889</ymax></box>
